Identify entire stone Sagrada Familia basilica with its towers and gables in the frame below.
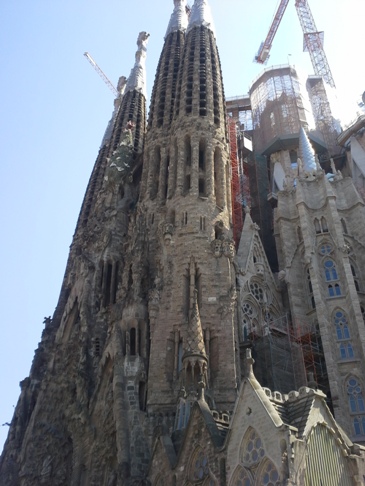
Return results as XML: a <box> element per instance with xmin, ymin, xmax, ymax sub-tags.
<box><xmin>0</xmin><ymin>0</ymin><xmax>365</xmax><ymax>486</ymax></box>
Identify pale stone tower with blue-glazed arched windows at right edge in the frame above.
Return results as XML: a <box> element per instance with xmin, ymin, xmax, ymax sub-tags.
<box><xmin>275</xmin><ymin>128</ymin><xmax>365</xmax><ymax>438</ymax></box>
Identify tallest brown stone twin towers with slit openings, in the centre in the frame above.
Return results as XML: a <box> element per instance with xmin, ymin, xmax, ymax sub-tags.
<box><xmin>140</xmin><ymin>1</ymin><xmax>236</xmax><ymax>413</ymax></box>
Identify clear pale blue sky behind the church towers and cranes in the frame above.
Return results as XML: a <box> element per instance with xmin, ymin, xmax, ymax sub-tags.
<box><xmin>0</xmin><ymin>0</ymin><xmax>365</xmax><ymax>449</ymax></box>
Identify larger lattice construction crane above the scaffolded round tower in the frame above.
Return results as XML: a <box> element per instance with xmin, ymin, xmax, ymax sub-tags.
<box><xmin>255</xmin><ymin>0</ymin><xmax>335</xmax><ymax>88</ymax></box>
